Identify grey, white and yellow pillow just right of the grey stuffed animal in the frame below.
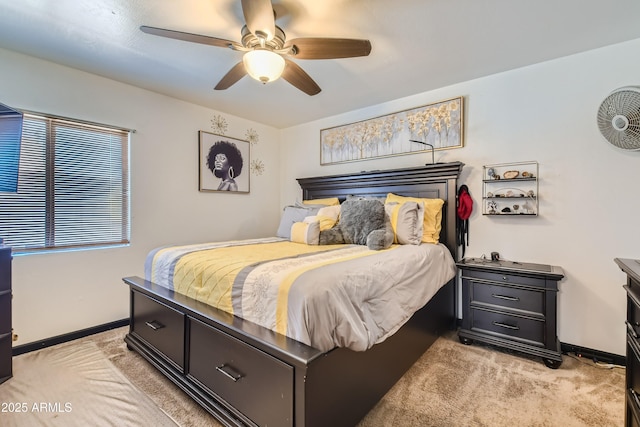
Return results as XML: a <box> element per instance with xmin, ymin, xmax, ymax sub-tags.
<box><xmin>384</xmin><ymin>202</ymin><xmax>424</xmax><ymax>245</ymax></box>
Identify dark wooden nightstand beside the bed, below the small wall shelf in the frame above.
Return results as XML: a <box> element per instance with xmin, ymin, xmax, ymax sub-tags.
<box><xmin>456</xmin><ymin>258</ymin><xmax>564</xmax><ymax>369</ymax></box>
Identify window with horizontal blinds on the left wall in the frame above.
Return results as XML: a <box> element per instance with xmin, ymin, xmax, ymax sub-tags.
<box><xmin>0</xmin><ymin>113</ymin><xmax>130</xmax><ymax>253</ymax></box>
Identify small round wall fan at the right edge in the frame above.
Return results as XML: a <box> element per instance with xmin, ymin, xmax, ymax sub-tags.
<box><xmin>598</xmin><ymin>86</ymin><xmax>640</xmax><ymax>150</ymax></box>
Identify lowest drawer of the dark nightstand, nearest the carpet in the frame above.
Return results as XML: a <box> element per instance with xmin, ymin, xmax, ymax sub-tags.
<box><xmin>471</xmin><ymin>308</ymin><xmax>545</xmax><ymax>346</ymax></box>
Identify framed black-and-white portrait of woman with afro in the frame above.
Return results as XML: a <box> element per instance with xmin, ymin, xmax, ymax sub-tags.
<box><xmin>199</xmin><ymin>130</ymin><xmax>251</xmax><ymax>193</ymax></box>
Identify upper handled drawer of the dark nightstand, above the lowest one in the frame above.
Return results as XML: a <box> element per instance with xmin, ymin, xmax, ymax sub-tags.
<box><xmin>471</xmin><ymin>281</ymin><xmax>545</xmax><ymax>316</ymax></box>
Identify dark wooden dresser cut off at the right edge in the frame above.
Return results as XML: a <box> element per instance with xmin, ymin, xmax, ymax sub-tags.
<box><xmin>614</xmin><ymin>258</ymin><xmax>640</xmax><ymax>427</ymax></box>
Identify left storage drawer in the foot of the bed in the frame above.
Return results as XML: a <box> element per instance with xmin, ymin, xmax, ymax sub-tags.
<box><xmin>131</xmin><ymin>291</ymin><xmax>185</xmax><ymax>372</ymax></box>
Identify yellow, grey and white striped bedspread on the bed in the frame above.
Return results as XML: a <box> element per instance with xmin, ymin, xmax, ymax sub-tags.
<box><xmin>145</xmin><ymin>237</ymin><xmax>456</xmax><ymax>351</ymax></box>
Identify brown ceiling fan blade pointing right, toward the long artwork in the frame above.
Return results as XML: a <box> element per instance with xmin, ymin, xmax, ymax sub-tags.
<box><xmin>284</xmin><ymin>37</ymin><xmax>371</xmax><ymax>59</ymax></box>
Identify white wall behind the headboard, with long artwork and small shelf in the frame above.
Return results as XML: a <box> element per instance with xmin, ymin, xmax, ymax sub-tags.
<box><xmin>280</xmin><ymin>39</ymin><xmax>640</xmax><ymax>355</ymax></box>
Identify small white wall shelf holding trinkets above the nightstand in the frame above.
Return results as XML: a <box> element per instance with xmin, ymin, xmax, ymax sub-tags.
<box><xmin>482</xmin><ymin>161</ymin><xmax>539</xmax><ymax>216</ymax></box>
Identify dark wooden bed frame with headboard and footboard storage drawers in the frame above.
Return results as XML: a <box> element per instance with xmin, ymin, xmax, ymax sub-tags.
<box><xmin>123</xmin><ymin>162</ymin><xmax>463</xmax><ymax>427</ymax></box>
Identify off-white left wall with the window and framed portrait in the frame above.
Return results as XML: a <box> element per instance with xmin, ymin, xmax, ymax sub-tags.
<box><xmin>0</xmin><ymin>49</ymin><xmax>280</xmax><ymax>345</ymax></box>
